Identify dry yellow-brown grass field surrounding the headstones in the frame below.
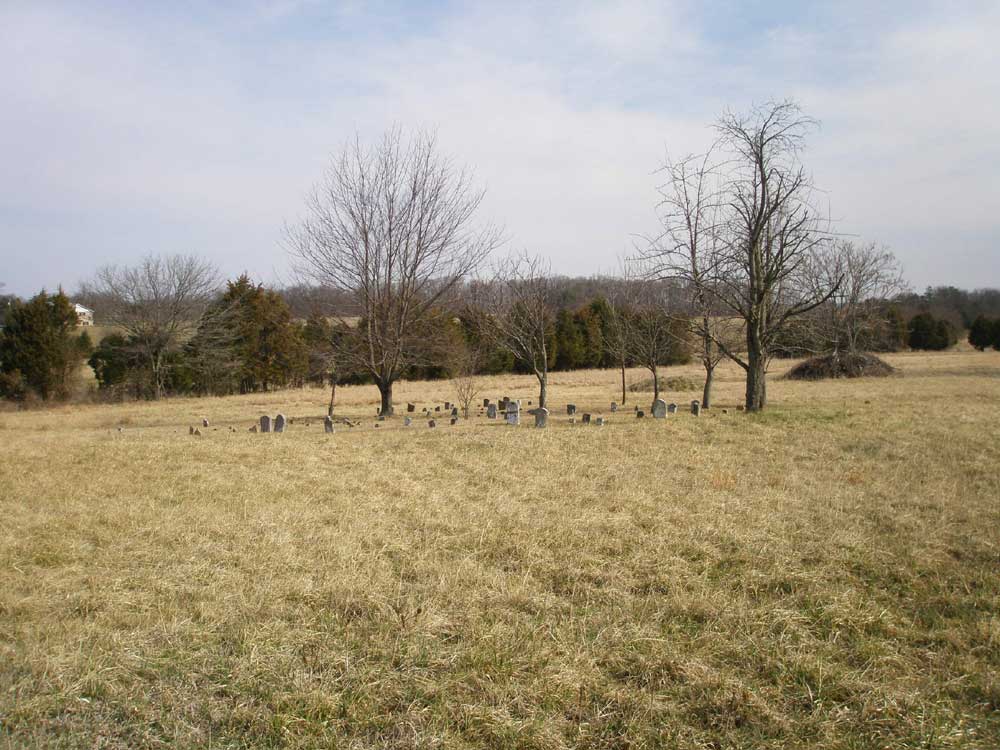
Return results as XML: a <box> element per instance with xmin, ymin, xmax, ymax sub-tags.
<box><xmin>0</xmin><ymin>351</ymin><xmax>1000</xmax><ymax>749</ymax></box>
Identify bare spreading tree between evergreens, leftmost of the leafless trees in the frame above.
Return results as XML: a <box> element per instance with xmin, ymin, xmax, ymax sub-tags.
<box><xmin>84</xmin><ymin>255</ymin><xmax>219</xmax><ymax>398</ymax></box>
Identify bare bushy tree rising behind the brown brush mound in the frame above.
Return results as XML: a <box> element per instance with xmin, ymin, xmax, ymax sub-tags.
<box><xmin>807</xmin><ymin>240</ymin><xmax>907</xmax><ymax>354</ymax></box>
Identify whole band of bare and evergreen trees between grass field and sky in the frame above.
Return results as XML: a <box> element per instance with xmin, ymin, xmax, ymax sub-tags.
<box><xmin>0</xmin><ymin>101</ymin><xmax>995</xmax><ymax>414</ymax></box>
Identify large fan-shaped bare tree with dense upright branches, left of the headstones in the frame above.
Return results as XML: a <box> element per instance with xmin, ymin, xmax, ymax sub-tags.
<box><xmin>287</xmin><ymin>130</ymin><xmax>501</xmax><ymax>415</ymax></box>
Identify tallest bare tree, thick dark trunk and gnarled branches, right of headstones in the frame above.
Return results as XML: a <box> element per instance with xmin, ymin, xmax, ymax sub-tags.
<box><xmin>649</xmin><ymin>101</ymin><xmax>839</xmax><ymax>411</ymax></box>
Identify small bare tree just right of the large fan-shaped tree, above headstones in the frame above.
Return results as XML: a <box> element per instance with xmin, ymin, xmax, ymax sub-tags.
<box><xmin>478</xmin><ymin>253</ymin><xmax>556</xmax><ymax>408</ymax></box>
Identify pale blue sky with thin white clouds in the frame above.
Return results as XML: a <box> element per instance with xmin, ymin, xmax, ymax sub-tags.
<box><xmin>0</xmin><ymin>0</ymin><xmax>1000</xmax><ymax>295</ymax></box>
